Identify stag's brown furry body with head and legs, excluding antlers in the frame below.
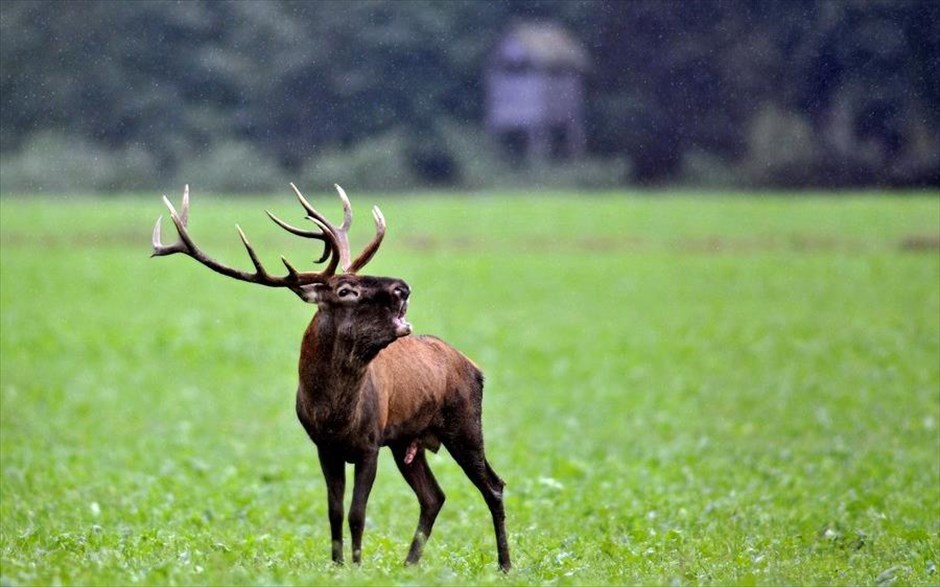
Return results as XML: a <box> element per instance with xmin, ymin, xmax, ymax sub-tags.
<box><xmin>297</xmin><ymin>275</ymin><xmax>511</xmax><ymax>570</ymax></box>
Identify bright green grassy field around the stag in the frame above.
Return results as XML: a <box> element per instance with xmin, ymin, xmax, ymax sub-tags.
<box><xmin>0</xmin><ymin>191</ymin><xmax>940</xmax><ymax>586</ymax></box>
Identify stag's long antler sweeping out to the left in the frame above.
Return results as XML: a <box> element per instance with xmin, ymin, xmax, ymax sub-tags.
<box><xmin>151</xmin><ymin>185</ymin><xmax>339</xmax><ymax>292</ymax></box>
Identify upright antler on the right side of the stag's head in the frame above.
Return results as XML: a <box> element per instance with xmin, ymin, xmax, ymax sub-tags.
<box><xmin>268</xmin><ymin>183</ymin><xmax>385</xmax><ymax>273</ymax></box>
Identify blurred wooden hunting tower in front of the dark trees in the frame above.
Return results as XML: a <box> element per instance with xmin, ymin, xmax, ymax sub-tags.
<box><xmin>486</xmin><ymin>22</ymin><xmax>588</xmax><ymax>162</ymax></box>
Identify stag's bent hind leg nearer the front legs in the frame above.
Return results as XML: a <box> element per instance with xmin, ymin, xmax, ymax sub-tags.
<box><xmin>392</xmin><ymin>443</ymin><xmax>445</xmax><ymax>565</ymax></box>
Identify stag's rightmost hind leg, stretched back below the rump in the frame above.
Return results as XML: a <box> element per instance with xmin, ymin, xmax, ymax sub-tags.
<box><xmin>444</xmin><ymin>435</ymin><xmax>512</xmax><ymax>571</ymax></box>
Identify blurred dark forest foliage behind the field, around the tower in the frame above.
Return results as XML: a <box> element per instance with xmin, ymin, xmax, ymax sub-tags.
<box><xmin>0</xmin><ymin>0</ymin><xmax>940</xmax><ymax>193</ymax></box>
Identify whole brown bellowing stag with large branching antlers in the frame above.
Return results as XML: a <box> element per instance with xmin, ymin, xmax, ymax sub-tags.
<box><xmin>151</xmin><ymin>183</ymin><xmax>512</xmax><ymax>572</ymax></box>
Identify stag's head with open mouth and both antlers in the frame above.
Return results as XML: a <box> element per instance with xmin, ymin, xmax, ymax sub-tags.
<box><xmin>151</xmin><ymin>183</ymin><xmax>411</xmax><ymax>342</ymax></box>
